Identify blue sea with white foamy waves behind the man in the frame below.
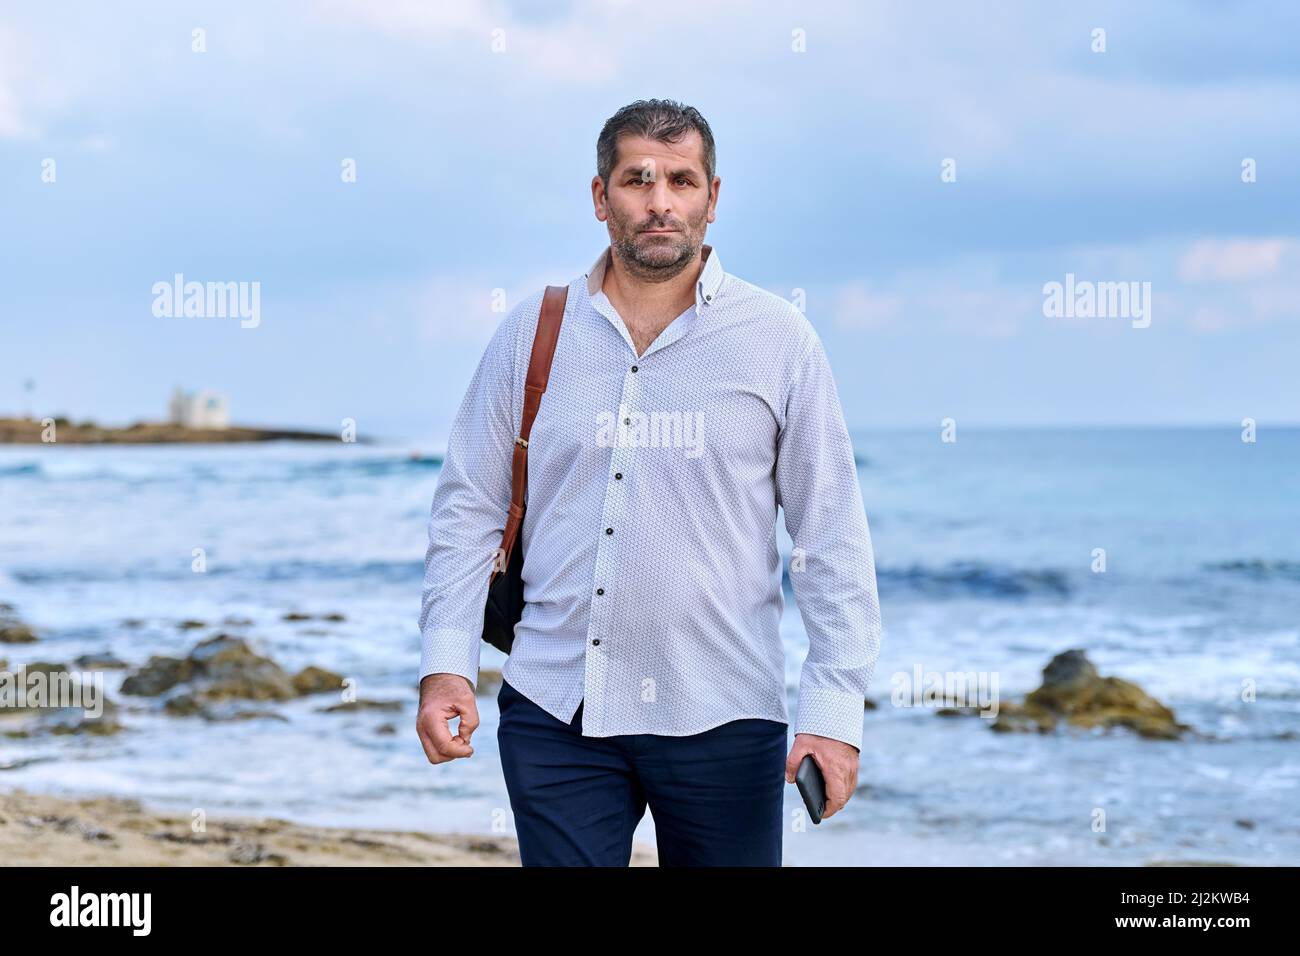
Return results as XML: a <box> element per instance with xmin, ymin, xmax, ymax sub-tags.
<box><xmin>0</xmin><ymin>427</ymin><xmax>1300</xmax><ymax>865</ymax></box>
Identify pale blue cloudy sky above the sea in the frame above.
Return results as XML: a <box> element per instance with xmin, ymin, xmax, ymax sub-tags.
<box><xmin>0</xmin><ymin>0</ymin><xmax>1300</xmax><ymax>441</ymax></box>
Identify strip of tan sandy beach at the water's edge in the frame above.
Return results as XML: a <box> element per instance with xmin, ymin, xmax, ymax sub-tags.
<box><xmin>0</xmin><ymin>790</ymin><xmax>658</xmax><ymax>866</ymax></box>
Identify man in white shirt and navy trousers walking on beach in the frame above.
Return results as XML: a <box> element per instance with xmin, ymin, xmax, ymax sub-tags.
<box><xmin>417</xmin><ymin>100</ymin><xmax>881</xmax><ymax>866</ymax></box>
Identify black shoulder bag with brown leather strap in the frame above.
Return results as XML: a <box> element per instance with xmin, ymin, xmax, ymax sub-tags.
<box><xmin>484</xmin><ymin>285</ymin><xmax>568</xmax><ymax>654</ymax></box>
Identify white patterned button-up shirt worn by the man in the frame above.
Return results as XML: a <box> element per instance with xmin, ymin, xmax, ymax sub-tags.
<box><xmin>420</xmin><ymin>245</ymin><xmax>881</xmax><ymax>749</ymax></box>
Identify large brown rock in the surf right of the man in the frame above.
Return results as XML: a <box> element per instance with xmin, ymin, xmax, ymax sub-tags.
<box><xmin>993</xmin><ymin>649</ymin><xmax>1191</xmax><ymax>740</ymax></box>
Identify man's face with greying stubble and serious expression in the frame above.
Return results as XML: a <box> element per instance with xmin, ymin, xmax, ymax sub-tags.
<box><xmin>592</xmin><ymin>130</ymin><xmax>722</xmax><ymax>281</ymax></box>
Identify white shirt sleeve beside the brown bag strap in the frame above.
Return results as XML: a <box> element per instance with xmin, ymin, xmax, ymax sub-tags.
<box><xmin>419</xmin><ymin>294</ymin><xmax>541</xmax><ymax>689</ymax></box>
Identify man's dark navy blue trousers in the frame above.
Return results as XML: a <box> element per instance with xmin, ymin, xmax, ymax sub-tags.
<box><xmin>497</xmin><ymin>680</ymin><xmax>789</xmax><ymax>866</ymax></box>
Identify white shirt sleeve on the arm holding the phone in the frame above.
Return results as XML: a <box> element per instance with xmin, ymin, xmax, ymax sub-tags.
<box><xmin>775</xmin><ymin>332</ymin><xmax>881</xmax><ymax>750</ymax></box>
